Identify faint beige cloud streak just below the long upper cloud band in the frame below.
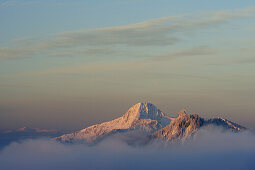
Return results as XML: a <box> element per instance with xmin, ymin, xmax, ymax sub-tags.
<box><xmin>27</xmin><ymin>46</ymin><xmax>216</xmax><ymax>75</ymax></box>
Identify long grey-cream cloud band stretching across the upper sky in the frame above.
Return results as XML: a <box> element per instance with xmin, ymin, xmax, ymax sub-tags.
<box><xmin>0</xmin><ymin>8</ymin><xmax>255</xmax><ymax>59</ymax></box>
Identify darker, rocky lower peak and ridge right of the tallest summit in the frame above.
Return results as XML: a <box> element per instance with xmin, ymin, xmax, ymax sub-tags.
<box><xmin>151</xmin><ymin>110</ymin><xmax>246</xmax><ymax>141</ymax></box>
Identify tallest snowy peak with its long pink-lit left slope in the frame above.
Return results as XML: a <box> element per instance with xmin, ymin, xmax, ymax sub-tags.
<box><xmin>56</xmin><ymin>103</ymin><xmax>171</xmax><ymax>143</ymax></box>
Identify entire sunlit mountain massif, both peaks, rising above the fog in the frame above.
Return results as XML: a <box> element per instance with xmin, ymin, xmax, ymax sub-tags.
<box><xmin>55</xmin><ymin>102</ymin><xmax>246</xmax><ymax>144</ymax></box>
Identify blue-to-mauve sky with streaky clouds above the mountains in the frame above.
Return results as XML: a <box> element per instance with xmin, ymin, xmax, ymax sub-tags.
<box><xmin>0</xmin><ymin>0</ymin><xmax>255</xmax><ymax>131</ymax></box>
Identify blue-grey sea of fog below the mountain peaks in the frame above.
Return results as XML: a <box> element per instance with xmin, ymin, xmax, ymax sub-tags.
<box><xmin>0</xmin><ymin>129</ymin><xmax>255</xmax><ymax>170</ymax></box>
